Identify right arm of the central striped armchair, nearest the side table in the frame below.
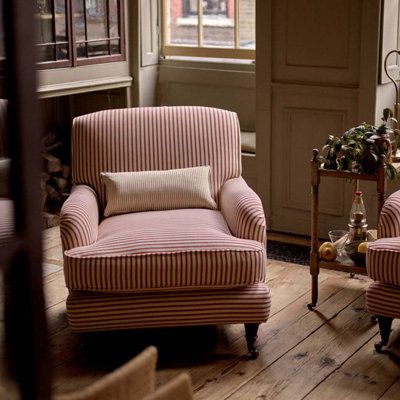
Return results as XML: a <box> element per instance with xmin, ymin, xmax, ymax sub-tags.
<box><xmin>220</xmin><ymin>177</ymin><xmax>267</xmax><ymax>245</ymax></box>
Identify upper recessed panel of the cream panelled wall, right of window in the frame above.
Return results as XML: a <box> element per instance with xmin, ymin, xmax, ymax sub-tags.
<box><xmin>272</xmin><ymin>0</ymin><xmax>362</xmax><ymax>85</ymax></box>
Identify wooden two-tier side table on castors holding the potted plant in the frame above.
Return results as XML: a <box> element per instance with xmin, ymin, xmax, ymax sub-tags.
<box><xmin>308</xmin><ymin>149</ymin><xmax>386</xmax><ymax>309</ymax></box>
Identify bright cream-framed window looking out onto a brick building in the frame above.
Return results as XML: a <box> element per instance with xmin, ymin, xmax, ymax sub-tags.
<box><xmin>162</xmin><ymin>0</ymin><xmax>255</xmax><ymax>59</ymax></box>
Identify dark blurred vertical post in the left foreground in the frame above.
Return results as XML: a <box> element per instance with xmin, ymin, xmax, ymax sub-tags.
<box><xmin>3</xmin><ymin>0</ymin><xmax>50</xmax><ymax>400</ymax></box>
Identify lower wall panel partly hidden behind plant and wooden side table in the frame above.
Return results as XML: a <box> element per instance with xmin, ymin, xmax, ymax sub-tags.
<box><xmin>270</xmin><ymin>85</ymin><xmax>358</xmax><ymax>235</ymax></box>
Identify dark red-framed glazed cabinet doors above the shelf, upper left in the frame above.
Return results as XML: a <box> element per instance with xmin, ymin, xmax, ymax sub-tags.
<box><xmin>36</xmin><ymin>0</ymin><xmax>125</xmax><ymax>68</ymax></box>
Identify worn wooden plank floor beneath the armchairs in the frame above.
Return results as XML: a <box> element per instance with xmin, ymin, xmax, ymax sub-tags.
<box><xmin>2</xmin><ymin>228</ymin><xmax>400</xmax><ymax>400</ymax></box>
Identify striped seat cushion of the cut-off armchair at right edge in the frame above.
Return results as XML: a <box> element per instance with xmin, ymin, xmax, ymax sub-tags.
<box><xmin>367</xmin><ymin>237</ymin><xmax>400</xmax><ymax>285</ymax></box>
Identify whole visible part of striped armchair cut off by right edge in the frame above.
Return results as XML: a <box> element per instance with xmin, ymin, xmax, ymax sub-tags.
<box><xmin>366</xmin><ymin>190</ymin><xmax>400</xmax><ymax>352</ymax></box>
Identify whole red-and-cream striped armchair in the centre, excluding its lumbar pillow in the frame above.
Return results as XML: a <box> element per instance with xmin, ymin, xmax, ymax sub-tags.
<box><xmin>61</xmin><ymin>107</ymin><xmax>270</xmax><ymax>357</ymax></box>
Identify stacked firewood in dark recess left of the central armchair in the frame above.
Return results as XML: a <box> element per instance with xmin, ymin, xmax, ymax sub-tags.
<box><xmin>41</xmin><ymin>129</ymin><xmax>71</xmax><ymax>219</ymax></box>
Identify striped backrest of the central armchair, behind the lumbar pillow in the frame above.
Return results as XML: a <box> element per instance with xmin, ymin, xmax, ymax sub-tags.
<box><xmin>72</xmin><ymin>107</ymin><xmax>241</xmax><ymax>210</ymax></box>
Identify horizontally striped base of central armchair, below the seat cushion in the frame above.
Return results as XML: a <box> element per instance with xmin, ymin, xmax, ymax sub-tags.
<box><xmin>67</xmin><ymin>283</ymin><xmax>271</xmax><ymax>332</ymax></box>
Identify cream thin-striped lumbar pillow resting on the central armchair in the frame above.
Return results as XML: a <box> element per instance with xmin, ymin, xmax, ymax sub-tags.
<box><xmin>100</xmin><ymin>166</ymin><xmax>217</xmax><ymax>217</ymax></box>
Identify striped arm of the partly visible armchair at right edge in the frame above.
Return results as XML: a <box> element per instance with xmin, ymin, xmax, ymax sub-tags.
<box><xmin>378</xmin><ymin>190</ymin><xmax>400</xmax><ymax>238</ymax></box>
